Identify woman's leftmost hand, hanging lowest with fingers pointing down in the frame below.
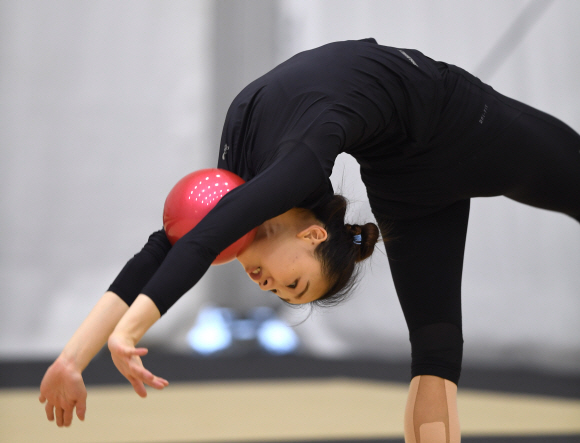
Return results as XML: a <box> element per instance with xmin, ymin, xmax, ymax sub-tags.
<box><xmin>38</xmin><ymin>358</ymin><xmax>87</xmax><ymax>427</ymax></box>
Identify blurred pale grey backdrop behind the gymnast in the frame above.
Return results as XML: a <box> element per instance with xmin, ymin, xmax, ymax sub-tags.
<box><xmin>0</xmin><ymin>0</ymin><xmax>580</xmax><ymax>374</ymax></box>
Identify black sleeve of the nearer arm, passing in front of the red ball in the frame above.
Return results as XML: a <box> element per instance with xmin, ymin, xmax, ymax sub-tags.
<box><xmin>142</xmin><ymin>144</ymin><xmax>329</xmax><ymax>314</ymax></box>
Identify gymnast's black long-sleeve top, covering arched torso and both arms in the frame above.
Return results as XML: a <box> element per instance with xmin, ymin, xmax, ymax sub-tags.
<box><xmin>110</xmin><ymin>39</ymin><xmax>508</xmax><ymax>313</ymax></box>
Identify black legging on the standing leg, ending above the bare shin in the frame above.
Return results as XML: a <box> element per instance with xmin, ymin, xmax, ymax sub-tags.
<box><xmin>377</xmin><ymin>200</ymin><xmax>470</xmax><ymax>384</ymax></box>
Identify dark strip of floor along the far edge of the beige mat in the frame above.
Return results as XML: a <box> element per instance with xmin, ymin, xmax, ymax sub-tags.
<box><xmin>0</xmin><ymin>349</ymin><xmax>580</xmax><ymax>400</ymax></box>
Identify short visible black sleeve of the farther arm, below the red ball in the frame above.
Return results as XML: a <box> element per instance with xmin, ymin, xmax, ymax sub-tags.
<box><xmin>109</xmin><ymin>229</ymin><xmax>171</xmax><ymax>306</ymax></box>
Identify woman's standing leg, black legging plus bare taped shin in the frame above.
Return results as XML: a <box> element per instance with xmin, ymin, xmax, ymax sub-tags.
<box><xmin>377</xmin><ymin>200</ymin><xmax>469</xmax><ymax>443</ymax></box>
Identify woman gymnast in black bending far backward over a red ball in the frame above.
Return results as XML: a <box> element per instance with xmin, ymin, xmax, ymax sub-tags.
<box><xmin>40</xmin><ymin>39</ymin><xmax>580</xmax><ymax>443</ymax></box>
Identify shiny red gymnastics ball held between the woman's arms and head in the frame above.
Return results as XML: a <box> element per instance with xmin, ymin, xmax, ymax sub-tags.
<box><xmin>163</xmin><ymin>168</ymin><xmax>256</xmax><ymax>265</ymax></box>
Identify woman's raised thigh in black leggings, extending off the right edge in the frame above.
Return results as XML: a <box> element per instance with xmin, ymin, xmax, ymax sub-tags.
<box><xmin>449</xmin><ymin>97</ymin><xmax>580</xmax><ymax>221</ymax></box>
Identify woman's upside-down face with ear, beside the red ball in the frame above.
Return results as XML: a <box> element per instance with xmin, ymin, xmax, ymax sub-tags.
<box><xmin>237</xmin><ymin>225</ymin><xmax>328</xmax><ymax>304</ymax></box>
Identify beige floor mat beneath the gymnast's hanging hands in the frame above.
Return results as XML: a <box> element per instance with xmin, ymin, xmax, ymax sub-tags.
<box><xmin>0</xmin><ymin>379</ymin><xmax>580</xmax><ymax>443</ymax></box>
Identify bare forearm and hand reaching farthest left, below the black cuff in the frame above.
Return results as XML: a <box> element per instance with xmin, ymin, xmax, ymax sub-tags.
<box><xmin>39</xmin><ymin>292</ymin><xmax>129</xmax><ymax>426</ymax></box>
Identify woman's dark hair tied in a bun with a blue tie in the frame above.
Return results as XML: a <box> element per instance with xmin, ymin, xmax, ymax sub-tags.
<box><xmin>312</xmin><ymin>194</ymin><xmax>379</xmax><ymax>307</ymax></box>
